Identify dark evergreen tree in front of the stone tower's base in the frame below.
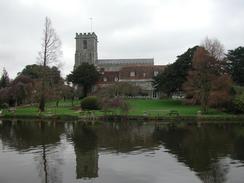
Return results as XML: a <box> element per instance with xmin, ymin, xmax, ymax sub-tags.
<box><xmin>67</xmin><ymin>63</ymin><xmax>100</xmax><ymax>97</ymax></box>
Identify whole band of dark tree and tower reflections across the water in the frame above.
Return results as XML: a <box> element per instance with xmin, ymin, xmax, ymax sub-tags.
<box><xmin>0</xmin><ymin>121</ymin><xmax>244</xmax><ymax>183</ymax></box>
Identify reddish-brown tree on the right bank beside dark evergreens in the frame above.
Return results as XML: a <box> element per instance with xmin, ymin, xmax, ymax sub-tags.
<box><xmin>184</xmin><ymin>47</ymin><xmax>231</xmax><ymax>112</ymax></box>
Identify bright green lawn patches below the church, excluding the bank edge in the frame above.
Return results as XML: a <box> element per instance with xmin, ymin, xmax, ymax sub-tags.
<box><xmin>0</xmin><ymin>99</ymin><xmax>227</xmax><ymax>116</ymax></box>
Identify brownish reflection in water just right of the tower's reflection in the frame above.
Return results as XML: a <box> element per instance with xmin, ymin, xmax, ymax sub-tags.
<box><xmin>96</xmin><ymin>122</ymin><xmax>159</xmax><ymax>153</ymax></box>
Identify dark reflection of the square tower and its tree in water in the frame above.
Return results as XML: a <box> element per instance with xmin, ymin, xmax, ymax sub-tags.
<box><xmin>71</xmin><ymin>123</ymin><xmax>98</xmax><ymax>179</ymax></box>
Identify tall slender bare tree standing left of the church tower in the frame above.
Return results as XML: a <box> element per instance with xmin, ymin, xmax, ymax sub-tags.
<box><xmin>37</xmin><ymin>17</ymin><xmax>62</xmax><ymax>112</ymax></box>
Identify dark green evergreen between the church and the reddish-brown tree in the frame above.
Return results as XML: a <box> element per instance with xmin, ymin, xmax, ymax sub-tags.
<box><xmin>153</xmin><ymin>46</ymin><xmax>198</xmax><ymax>96</ymax></box>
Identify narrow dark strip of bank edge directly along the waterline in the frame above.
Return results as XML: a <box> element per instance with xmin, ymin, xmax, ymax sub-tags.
<box><xmin>0</xmin><ymin>115</ymin><xmax>244</xmax><ymax>124</ymax></box>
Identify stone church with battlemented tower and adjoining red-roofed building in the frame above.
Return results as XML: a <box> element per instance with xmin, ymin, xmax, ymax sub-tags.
<box><xmin>74</xmin><ymin>32</ymin><xmax>165</xmax><ymax>98</ymax></box>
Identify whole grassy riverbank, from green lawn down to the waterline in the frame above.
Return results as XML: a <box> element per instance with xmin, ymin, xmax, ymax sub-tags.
<box><xmin>0</xmin><ymin>99</ymin><xmax>244</xmax><ymax>122</ymax></box>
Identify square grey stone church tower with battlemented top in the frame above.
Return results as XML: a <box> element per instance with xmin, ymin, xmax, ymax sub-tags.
<box><xmin>75</xmin><ymin>32</ymin><xmax>97</xmax><ymax>67</ymax></box>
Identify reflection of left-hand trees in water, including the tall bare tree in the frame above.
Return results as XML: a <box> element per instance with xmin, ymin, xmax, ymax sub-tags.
<box><xmin>0</xmin><ymin>121</ymin><xmax>64</xmax><ymax>183</ymax></box>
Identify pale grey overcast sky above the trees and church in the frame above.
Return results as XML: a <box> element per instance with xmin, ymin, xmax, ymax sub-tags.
<box><xmin>0</xmin><ymin>0</ymin><xmax>244</xmax><ymax>78</ymax></box>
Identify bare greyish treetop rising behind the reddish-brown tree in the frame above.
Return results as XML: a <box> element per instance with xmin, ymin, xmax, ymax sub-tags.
<box><xmin>201</xmin><ymin>37</ymin><xmax>225</xmax><ymax>61</ymax></box>
